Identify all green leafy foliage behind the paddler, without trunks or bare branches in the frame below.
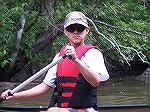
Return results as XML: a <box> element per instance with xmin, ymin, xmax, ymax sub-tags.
<box><xmin>0</xmin><ymin>0</ymin><xmax>150</xmax><ymax>73</ymax></box>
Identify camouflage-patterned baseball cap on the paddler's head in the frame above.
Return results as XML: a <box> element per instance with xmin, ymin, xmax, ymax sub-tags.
<box><xmin>64</xmin><ymin>11</ymin><xmax>89</xmax><ymax>29</ymax></box>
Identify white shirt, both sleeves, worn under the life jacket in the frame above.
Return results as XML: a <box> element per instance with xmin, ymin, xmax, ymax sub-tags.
<box><xmin>43</xmin><ymin>48</ymin><xmax>109</xmax><ymax>87</ymax></box>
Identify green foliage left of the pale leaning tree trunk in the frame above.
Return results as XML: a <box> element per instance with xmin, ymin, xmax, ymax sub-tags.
<box><xmin>0</xmin><ymin>3</ymin><xmax>23</xmax><ymax>68</ymax></box>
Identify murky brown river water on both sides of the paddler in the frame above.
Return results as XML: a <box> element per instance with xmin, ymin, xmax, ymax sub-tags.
<box><xmin>0</xmin><ymin>75</ymin><xmax>150</xmax><ymax>109</ymax></box>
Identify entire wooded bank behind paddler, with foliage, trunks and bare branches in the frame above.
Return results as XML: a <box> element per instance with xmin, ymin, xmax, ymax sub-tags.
<box><xmin>0</xmin><ymin>0</ymin><xmax>150</xmax><ymax>81</ymax></box>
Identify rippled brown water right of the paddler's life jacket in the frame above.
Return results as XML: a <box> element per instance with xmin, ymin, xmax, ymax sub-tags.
<box><xmin>98</xmin><ymin>76</ymin><xmax>150</xmax><ymax>105</ymax></box>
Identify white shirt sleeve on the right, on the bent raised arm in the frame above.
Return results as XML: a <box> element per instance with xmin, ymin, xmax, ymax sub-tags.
<box><xmin>81</xmin><ymin>49</ymin><xmax>109</xmax><ymax>81</ymax></box>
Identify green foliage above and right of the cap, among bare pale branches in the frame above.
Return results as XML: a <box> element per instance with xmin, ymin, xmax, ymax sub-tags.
<box><xmin>55</xmin><ymin>0</ymin><xmax>150</xmax><ymax>63</ymax></box>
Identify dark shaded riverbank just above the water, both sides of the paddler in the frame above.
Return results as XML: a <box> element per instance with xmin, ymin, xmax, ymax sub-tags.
<box><xmin>0</xmin><ymin>59</ymin><xmax>150</xmax><ymax>83</ymax></box>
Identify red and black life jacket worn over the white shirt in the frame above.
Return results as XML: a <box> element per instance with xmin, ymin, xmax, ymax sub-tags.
<box><xmin>51</xmin><ymin>44</ymin><xmax>97</xmax><ymax>108</ymax></box>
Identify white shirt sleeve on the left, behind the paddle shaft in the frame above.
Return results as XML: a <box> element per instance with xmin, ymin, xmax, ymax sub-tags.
<box><xmin>43</xmin><ymin>53</ymin><xmax>59</xmax><ymax>87</ymax></box>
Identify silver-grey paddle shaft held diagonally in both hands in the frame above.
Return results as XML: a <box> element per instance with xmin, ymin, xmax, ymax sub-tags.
<box><xmin>0</xmin><ymin>54</ymin><xmax>68</xmax><ymax>102</ymax></box>
